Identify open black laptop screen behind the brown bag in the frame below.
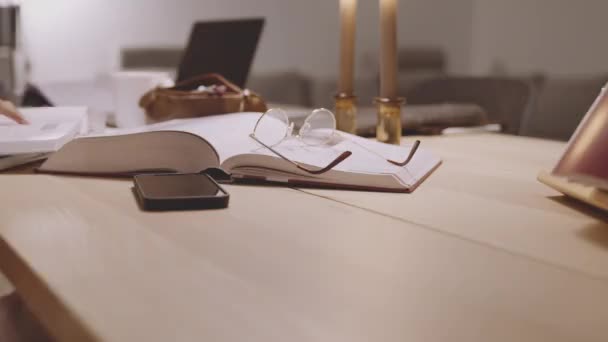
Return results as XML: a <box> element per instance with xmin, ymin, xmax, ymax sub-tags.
<box><xmin>177</xmin><ymin>18</ymin><xmax>265</xmax><ymax>88</ymax></box>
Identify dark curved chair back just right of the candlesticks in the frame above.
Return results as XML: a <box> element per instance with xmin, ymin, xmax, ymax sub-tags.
<box><xmin>406</xmin><ymin>77</ymin><xmax>532</xmax><ymax>134</ymax></box>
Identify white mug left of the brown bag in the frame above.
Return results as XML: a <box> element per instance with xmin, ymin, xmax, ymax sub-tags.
<box><xmin>112</xmin><ymin>71</ymin><xmax>172</xmax><ymax>128</ymax></box>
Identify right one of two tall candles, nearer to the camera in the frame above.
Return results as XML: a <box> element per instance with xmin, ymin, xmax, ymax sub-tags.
<box><xmin>380</xmin><ymin>0</ymin><xmax>397</xmax><ymax>99</ymax></box>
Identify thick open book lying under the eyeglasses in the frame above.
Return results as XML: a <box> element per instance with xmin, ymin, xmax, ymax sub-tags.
<box><xmin>39</xmin><ymin>113</ymin><xmax>441</xmax><ymax>192</ymax></box>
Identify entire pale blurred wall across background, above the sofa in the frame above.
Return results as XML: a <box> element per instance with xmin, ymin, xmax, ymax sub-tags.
<box><xmin>16</xmin><ymin>0</ymin><xmax>608</xmax><ymax>81</ymax></box>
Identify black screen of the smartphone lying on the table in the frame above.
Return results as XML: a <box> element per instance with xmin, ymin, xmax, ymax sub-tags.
<box><xmin>137</xmin><ymin>174</ymin><xmax>224</xmax><ymax>198</ymax></box>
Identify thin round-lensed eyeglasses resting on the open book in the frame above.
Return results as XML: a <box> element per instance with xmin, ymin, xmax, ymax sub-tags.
<box><xmin>249</xmin><ymin>108</ymin><xmax>420</xmax><ymax>175</ymax></box>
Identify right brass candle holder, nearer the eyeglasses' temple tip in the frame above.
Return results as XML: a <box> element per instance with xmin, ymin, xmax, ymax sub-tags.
<box><xmin>374</xmin><ymin>97</ymin><xmax>405</xmax><ymax>145</ymax></box>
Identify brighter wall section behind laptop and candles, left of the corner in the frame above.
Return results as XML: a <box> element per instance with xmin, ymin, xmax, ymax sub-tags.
<box><xmin>23</xmin><ymin>0</ymin><xmax>473</xmax><ymax>81</ymax></box>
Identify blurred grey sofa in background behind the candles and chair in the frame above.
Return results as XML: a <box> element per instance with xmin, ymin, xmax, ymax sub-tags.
<box><xmin>248</xmin><ymin>72</ymin><xmax>608</xmax><ymax>141</ymax></box>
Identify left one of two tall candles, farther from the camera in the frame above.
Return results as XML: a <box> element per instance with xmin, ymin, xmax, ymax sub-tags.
<box><xmin>338</xmin><ymin>0</ymin><xmax>357</xmax><ymax>95</ymax></box>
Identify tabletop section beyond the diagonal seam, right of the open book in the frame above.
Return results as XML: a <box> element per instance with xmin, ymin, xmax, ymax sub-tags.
<box><xmin>305</xmin><ymin>134</ymin><xmax>608</xmax><ymax>280</ymax></box>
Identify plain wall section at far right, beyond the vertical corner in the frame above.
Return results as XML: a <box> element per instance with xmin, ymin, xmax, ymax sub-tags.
<box><xmin>471</xmin><ymin>0</ymin><xmax>608</xmax><ymax>75</ymax></box>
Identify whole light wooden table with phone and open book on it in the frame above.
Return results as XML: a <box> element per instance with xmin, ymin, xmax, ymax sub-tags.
<box><xmin>0</xmin><ymin>135</ymin><xmax>608</xmax><ymax>342</ymax></box>
